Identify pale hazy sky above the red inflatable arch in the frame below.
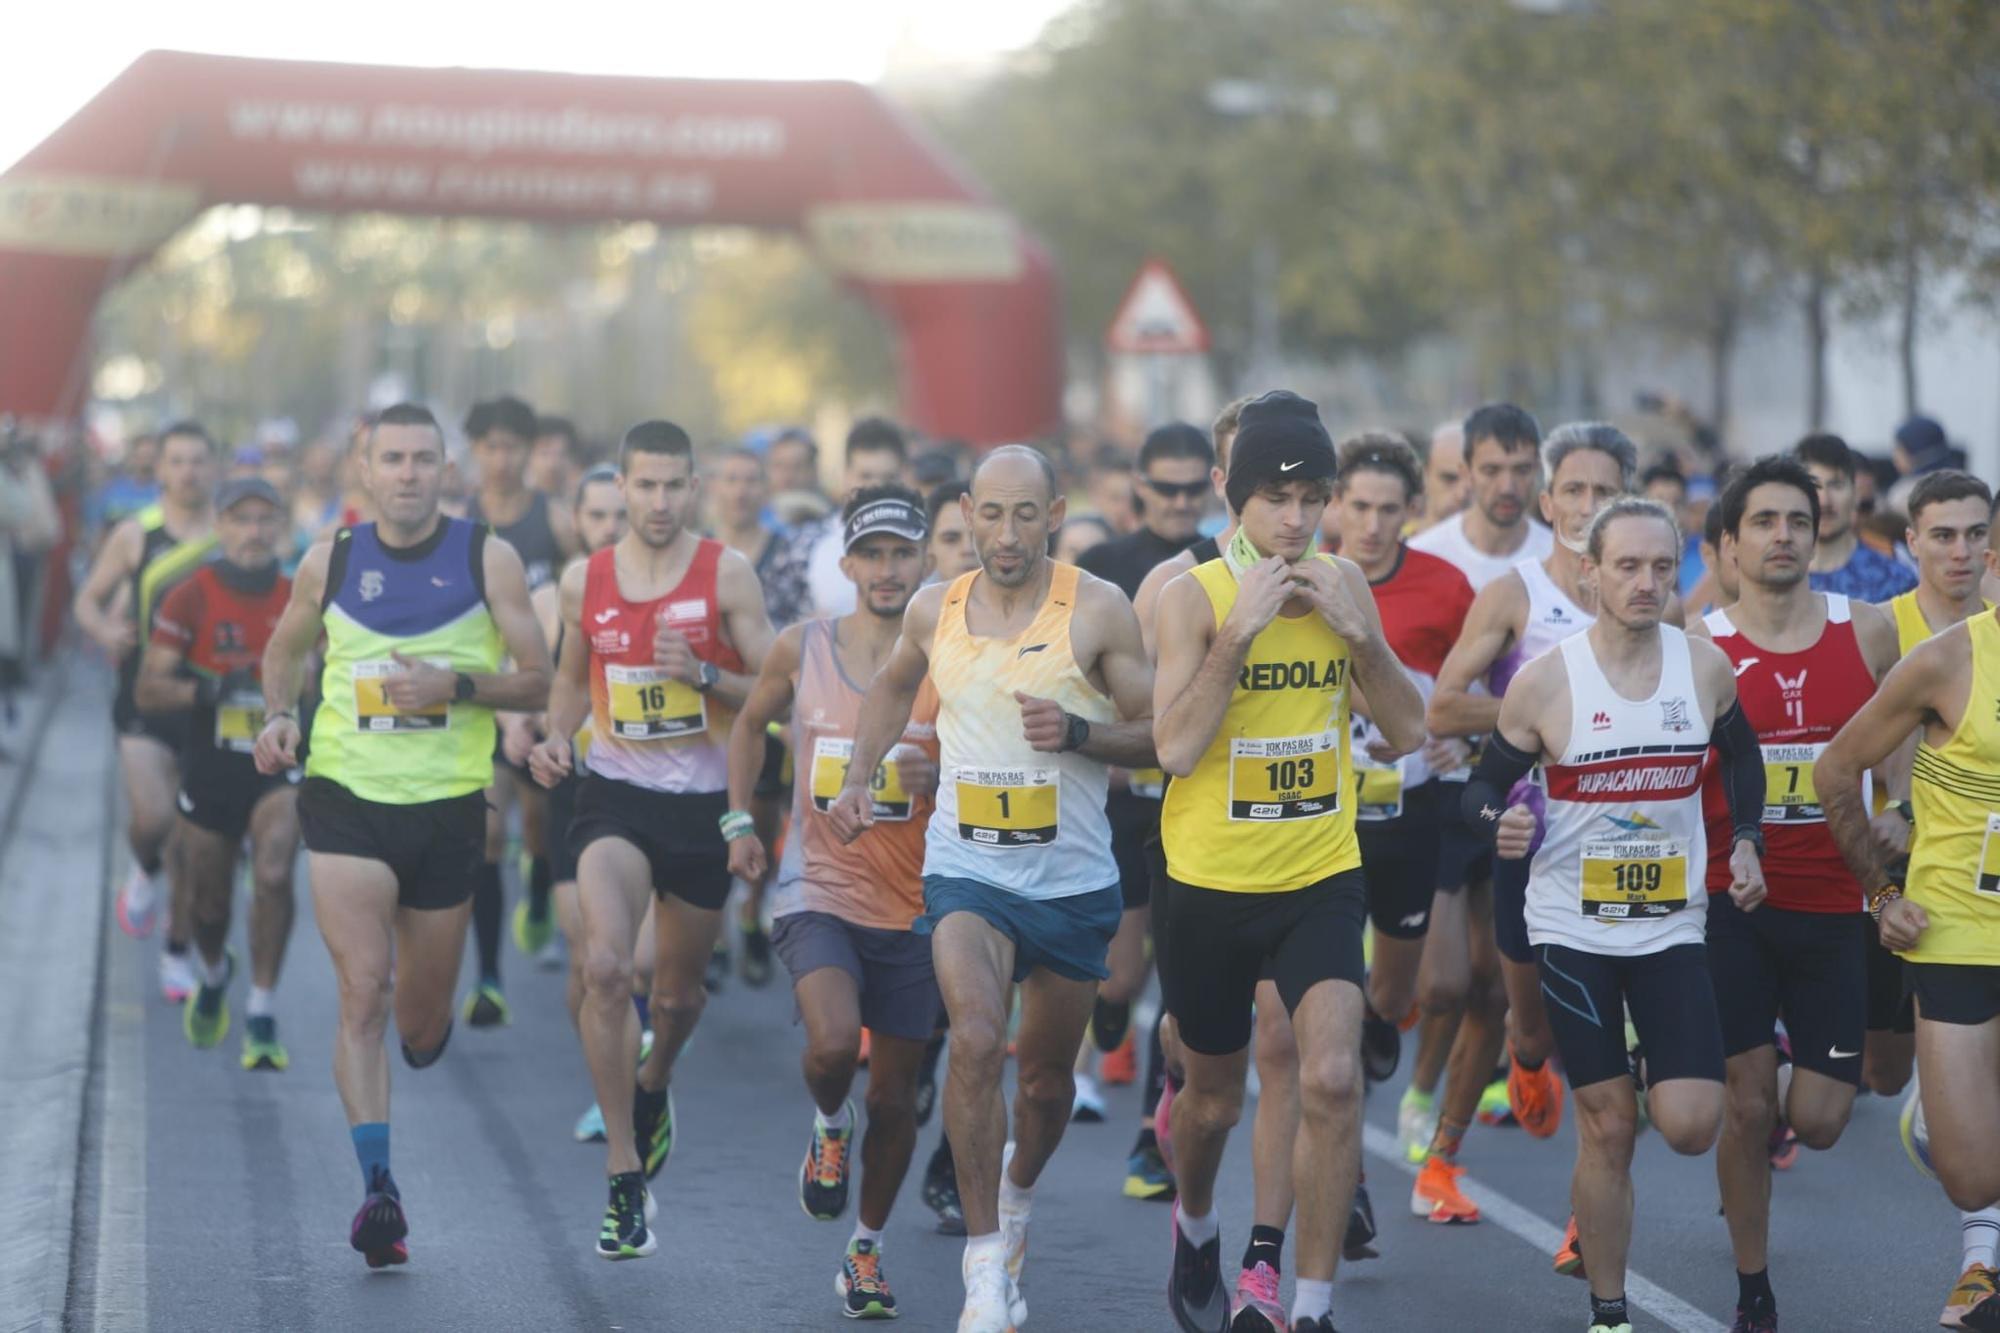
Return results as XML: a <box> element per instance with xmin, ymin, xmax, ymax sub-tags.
<box><xmin>0</xmin><ymin>0</ymin><xmax>1072</xmax><ymax>170</ymax></box>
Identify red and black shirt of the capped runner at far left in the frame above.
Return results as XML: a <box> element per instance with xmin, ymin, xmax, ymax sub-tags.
<box><xmin>152</xmin><ymin>560</ymin><xmax>292</xmax><ymax>755</ymax></box>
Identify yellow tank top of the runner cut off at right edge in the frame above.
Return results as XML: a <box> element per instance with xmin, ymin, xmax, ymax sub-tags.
<box><xmin>1902</xmin><ymin>610</ymin><xmax>2000</xmax><ymax>967</ymax></box>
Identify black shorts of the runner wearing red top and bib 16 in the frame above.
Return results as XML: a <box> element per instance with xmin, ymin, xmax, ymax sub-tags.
<box><xmin>570</xmin><ymin>773</ymin><xmax>730</xmax><ymax>911</ymax></box>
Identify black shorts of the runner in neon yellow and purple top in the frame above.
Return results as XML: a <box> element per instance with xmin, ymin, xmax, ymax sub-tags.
<box><xmin>298</xmin><ymin>777</ymin><xmax>486</xmax><ymax>911</ymax></box>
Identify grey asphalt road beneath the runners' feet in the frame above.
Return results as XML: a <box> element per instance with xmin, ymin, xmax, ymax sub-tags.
<box><xmin>23</xmin><ymin>664</ymin><xmax>1958</xmax><ymax>1331</ymax></box>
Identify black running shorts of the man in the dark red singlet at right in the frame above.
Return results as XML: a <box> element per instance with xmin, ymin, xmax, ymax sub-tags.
<box><xmin>1708</xmin><ymin>893</ymin><xmax>1868</xmax><ymax>1087</ymax></box>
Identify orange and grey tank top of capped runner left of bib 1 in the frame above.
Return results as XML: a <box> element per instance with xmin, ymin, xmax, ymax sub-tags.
<box><xmin>770</xmin><ymin>620</ymin><xmax>938</xmax><ymax>931</ymax></box>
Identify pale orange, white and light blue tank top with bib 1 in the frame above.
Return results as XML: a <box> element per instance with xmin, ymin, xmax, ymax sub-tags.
<box><xmin>924</xmin><ymin>560</ymin><xmax>1118</xmax><ymax>899</ymax></box>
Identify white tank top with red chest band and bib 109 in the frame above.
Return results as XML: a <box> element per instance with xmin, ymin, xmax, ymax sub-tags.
<box><xmin>1528</xmin><ymin>624</ymin><xmax>1708</xmax><ymax>957</ymax></box>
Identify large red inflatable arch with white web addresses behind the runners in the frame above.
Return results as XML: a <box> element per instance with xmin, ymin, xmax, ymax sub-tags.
<box><xmin>0</xmin><ymin>52</ymin><xmax>1062</xmax><ymax>444</ymax></box>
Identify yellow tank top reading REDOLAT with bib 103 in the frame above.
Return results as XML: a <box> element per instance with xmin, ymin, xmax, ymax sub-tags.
<box><xmin>1160</xmin><ymin>556</ymin><xmax>1362</xmax><ymax>893</ymax></box>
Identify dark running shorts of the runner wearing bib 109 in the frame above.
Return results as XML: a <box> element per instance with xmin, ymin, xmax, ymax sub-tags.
<box><xmin>1534</xmin><ymin>932</ymin><xmax>1722</xmax><ymax>1089</ymax></box>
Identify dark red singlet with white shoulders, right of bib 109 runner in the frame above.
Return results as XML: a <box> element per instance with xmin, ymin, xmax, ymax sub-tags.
<box><xmin>1702</xmin><ymin>592</ymin><xmax>1876</xmax><ymax>913</ymax></box>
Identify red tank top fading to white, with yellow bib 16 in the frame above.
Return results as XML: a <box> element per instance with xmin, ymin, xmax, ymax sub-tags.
<box><xmin>584</xmin><ymin>536</ymin><xmax>744</xmax><ymax>793</ymax></box>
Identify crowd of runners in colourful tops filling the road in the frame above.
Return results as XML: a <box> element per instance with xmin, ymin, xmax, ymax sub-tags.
<box><xmin>74</xmin><ymin>390</ymin><xmax>2000</xmax><ymax>1333</ymax></box>
